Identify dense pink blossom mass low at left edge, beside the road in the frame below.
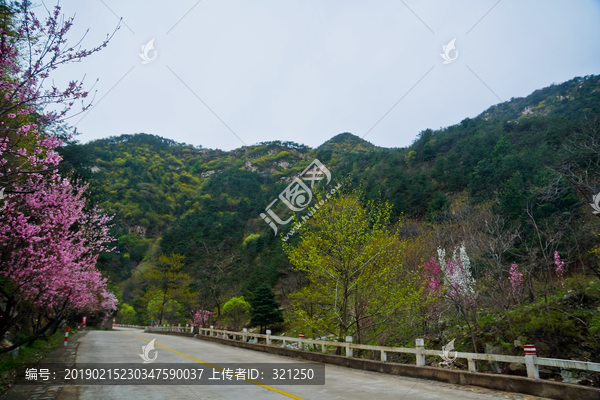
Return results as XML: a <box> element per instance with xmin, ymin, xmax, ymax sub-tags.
<box><xmin>0</xmin><ymin>175</ymin><xmax>116</xmax><ymax>352</ymax></box>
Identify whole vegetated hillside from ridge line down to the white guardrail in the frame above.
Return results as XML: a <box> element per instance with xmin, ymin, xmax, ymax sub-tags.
<box><xmin>60</xmin><ymin>76</ymin><xmax>600</xmax><ymax>385</ymax></box>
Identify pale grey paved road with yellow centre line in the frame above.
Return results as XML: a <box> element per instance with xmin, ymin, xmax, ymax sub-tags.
<box><xmin>59</xmin><ymin>328</ymin><xmax>531</xmax><ymax>400</ymax></box>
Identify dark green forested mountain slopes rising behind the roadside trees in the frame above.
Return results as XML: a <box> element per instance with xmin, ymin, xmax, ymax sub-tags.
<box><xmin>60</xmin><ymin>75</ymin><xmax>600</xmax><ymax>312</ymax></box>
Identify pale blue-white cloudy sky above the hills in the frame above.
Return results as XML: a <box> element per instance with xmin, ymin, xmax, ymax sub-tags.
<box><xmin>42</xmin><ymin>0</ymin><xmax>600</xmax><ymax>150</ymax></box>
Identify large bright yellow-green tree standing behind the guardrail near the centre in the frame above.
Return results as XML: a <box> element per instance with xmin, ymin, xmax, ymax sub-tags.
<box><xmin>283</xmin><ymin>191</ymin><xmax>422</xmax><ymax>342</ymax></box>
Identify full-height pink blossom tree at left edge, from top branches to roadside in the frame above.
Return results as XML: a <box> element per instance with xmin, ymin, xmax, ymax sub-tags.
<box><xmin>0</xmin><ymin>1</ymin><xmax>117</xmax><ymax>353</ymax></box>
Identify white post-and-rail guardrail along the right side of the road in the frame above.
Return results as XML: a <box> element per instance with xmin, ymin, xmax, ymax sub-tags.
<box><xmin>176</xmin><ymin>327</ymin><xmax>600</xmax><ymax>379</ymax></box>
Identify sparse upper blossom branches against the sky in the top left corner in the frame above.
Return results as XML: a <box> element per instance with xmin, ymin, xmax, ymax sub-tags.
<box><xmin>0</xmin><ymin>0</ymin><xmax>118</xmax><ymax>193</ymax></box>
